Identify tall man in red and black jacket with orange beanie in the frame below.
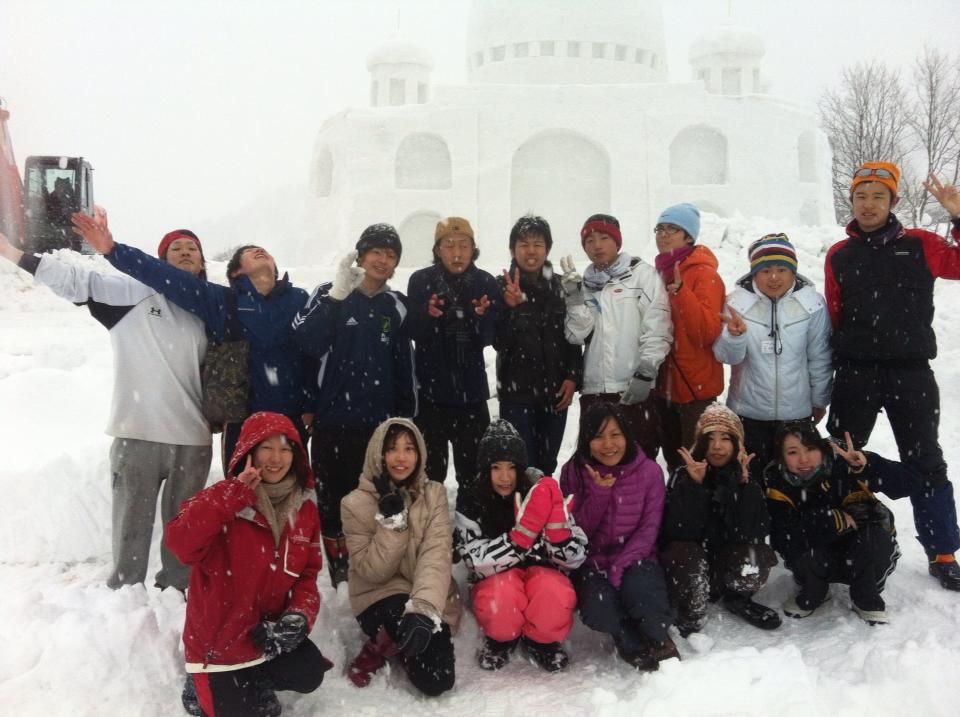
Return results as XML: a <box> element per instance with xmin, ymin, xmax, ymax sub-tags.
<box><xmin>824</xmin><ymin>162</ymin><xmax>960</xmax><ymax>591</ymax></box>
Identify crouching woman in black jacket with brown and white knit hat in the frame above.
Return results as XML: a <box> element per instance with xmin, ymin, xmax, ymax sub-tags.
<box><xmin>660</xmin><ymin>403</ymin><xmax>780</xmax><ymax>637</ymax></box>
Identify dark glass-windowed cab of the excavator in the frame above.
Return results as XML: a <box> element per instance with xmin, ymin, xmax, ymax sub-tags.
<box><xmin>23</xmin><ymin>157</ymin><xmax>96</xmax><ymax>254</ymax></box>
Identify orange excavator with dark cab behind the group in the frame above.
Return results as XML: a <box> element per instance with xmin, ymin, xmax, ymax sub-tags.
<box><xmin>0</xmin><ymin>98</ymin><xmax>94</xmax><ymax>254</ymax></box>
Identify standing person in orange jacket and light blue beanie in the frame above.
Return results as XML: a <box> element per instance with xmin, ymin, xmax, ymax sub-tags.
<box><xmin>653</xmin><ymin>203</ymin><xmax>726</xmax><ymax>474</ymax></box>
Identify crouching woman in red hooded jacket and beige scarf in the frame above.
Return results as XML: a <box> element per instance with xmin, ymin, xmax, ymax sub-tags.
<box><xmin>166</xmin><ymin>412</ymin><xmax>332</xmax><ymax>717</ymax></box>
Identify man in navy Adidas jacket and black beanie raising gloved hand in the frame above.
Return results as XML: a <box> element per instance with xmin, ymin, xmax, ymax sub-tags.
<box><xmin>293</xmin><ymin>224</ymin><xmax>417</xmax><ymax>586</ymax></box>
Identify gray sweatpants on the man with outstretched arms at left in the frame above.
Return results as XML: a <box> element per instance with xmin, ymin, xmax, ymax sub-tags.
<box><xmin>107</xmin><ymin>438</ymin><xmax>213</xmax><ymax>590</ymax></box>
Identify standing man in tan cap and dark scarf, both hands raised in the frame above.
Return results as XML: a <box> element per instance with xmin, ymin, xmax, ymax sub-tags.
<box><xmin>407</xmin><ymin>217</ymin><xmax>501</xmax><ymax>501</ymax></box>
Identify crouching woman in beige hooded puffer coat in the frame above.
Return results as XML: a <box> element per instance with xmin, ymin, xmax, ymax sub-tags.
<box><xmin>340</xmin><ymin>418</ymin><xmax>461</xmax><ymax>696</ymax></box>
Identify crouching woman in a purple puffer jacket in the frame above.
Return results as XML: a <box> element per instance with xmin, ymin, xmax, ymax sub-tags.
<box><xmin>560</xmin><ymin>403</ymin><xmax>679</xmax><ymax>670</ymax></box>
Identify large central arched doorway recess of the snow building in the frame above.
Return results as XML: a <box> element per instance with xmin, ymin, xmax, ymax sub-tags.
<box><xmin>509</xmin><ymin>130</ymin><xmax>611</xmax><ymax>256</ymax></box>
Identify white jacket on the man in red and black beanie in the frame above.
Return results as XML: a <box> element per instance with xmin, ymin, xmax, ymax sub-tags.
<box><xmin>566</xmin><ymin>259</ymin><xmax>673</xmax><ymax>394</ymax></box>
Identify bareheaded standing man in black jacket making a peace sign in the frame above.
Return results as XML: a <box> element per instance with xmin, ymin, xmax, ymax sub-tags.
<box><xmin>493</xmin><ymin>215</ymin><xmax>583</xmax><ymax>475</ymax></box>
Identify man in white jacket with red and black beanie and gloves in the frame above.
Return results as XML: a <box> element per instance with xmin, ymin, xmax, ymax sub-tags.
<box><xmin>560</xmin><ymin>214</ymin><xmax>673</xmax><ymax>460</ymax></box>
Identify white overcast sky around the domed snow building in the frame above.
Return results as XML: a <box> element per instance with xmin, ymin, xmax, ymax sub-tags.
<box><xmin>0</xmin><ymin>0</ymin><xmax>960</xmax><ymax>255</ymax></box>
